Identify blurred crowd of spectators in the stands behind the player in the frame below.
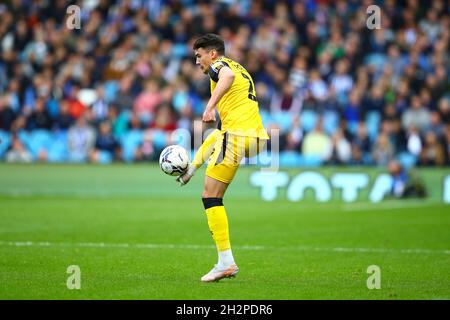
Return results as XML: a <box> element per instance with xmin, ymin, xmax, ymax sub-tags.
<box><xmin>0</xmin><ymin>0</ymin><xmax>450</xmax><ymax>166</ymax></box>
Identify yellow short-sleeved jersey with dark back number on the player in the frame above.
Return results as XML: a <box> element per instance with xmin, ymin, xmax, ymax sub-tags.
<box><xmin>209</xmin><ymin>57</ymin><xmax>269</xmax><ymax>140</ymax></box>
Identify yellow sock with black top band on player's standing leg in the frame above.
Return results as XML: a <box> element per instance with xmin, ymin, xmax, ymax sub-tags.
<box><xmin>203</xmin><ymin>198</ymin><xmax>231</xmax><ymax>251</ymax></box>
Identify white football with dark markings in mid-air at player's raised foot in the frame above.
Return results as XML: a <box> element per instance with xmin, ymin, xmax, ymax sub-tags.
<box><xmin>159</xmin><ymin>145</ymin><xmax>189</xmax><ymax>176</ymax></box>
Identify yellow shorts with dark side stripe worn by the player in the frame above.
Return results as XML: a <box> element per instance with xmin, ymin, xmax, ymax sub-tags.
<box><xmin>206</xmin><ymin>132</ymin><xmax>266</xmax><ymax>183</ymax></box>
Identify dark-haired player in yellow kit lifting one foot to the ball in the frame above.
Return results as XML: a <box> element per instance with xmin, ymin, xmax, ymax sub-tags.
<box><xmin>177</xmin><ymin>34</ymin><xmax>269</xmax><ymax>282</ymax></box>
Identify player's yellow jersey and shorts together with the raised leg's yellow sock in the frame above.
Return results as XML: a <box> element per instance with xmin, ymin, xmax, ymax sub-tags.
<box><xmin>192</xmin><ymin>57</ymin><xmax>269</xmax><ymax>183</ymax></box>
